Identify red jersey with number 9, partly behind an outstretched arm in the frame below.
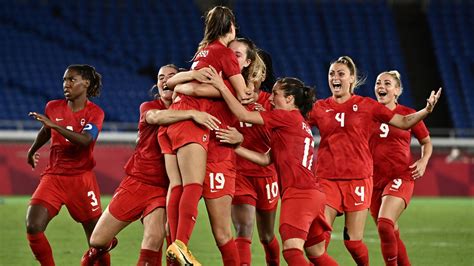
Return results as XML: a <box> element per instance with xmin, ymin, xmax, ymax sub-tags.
<box><xmin>370</xmin><ymin>104</ymin><xmax>430</xmax><ymax>188</ymax></box>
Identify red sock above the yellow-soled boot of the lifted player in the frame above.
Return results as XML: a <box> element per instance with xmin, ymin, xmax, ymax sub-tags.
<box><xmin>176</xmin><ymin>183</ymin><xmax>202</xmax><ymax>245</ymax></box>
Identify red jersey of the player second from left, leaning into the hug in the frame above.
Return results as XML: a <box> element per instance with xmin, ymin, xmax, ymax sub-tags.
<box><xmin>124</xmin><ymin>100</ymin><xmax>169</xmax><ymax>187</ymax></box>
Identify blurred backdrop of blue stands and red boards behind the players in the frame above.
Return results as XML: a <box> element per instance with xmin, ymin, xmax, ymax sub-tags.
<box><xmin>0</xmin><ymin>0</ymin><xmax>474</xmax><ymax>197</ymax></box>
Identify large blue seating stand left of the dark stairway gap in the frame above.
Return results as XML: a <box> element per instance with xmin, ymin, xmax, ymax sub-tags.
<box><xmin>0</xmin><ymin>0</ymin><xmax>412</xmax><ymax>122</ymax></box>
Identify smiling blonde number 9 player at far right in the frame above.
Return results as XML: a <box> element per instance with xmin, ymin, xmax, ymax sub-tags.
<box><xmin>370</xmin><ymin>70</ymin><xmax>433</xmax><ymax>265</ymax></box>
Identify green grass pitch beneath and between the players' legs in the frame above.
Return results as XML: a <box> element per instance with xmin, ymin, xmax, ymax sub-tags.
<box><xmin>0</xmin><ymin>197</ymin><xmax>474</xmax><ymax>265</ymax></box>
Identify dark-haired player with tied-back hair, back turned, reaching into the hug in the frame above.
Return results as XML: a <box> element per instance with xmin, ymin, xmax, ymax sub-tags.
<box><xmin>211</xmin><ymin>74</ymin><xmax>337</xmax><ymax>265</ymax></box>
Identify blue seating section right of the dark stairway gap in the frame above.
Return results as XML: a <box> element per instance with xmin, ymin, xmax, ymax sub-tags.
<box><xmin>427</xmin><ymin>0</ymin><xmax>474</xmax><ymax>129</ymax></box>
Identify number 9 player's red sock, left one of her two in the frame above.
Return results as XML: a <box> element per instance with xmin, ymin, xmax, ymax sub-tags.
<box><xmin>377</xmin><ymin>218</ymin><xmax>398</xmax><ymax>266</ymax></box>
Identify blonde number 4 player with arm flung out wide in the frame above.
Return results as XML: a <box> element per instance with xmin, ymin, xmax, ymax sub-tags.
<box><xmin>308</xmin><ymin>56</ymin><xmax>441</xmax><ymax>265</ymax></box>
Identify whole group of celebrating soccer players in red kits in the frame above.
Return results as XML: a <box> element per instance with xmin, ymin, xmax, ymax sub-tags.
<box><xmin>27</xmin><ymin>6</ymin><xmax>441</xmax><ymax>265</ymax></box>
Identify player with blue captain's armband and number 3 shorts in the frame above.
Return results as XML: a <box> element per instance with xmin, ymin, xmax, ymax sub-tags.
<box><xmin>26</xmin><ymin>65</ymin><xmax>110</xmax><ymax>265</ymax></box>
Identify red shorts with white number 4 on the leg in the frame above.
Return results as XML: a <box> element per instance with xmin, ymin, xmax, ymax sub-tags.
<box><xmin>319</xmin><ymin>178</ymin><xmax>373</xmax><ymax>214</ymax></box>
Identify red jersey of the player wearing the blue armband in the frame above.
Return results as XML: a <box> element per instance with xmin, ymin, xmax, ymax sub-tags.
<box><xmin>42</xmin><ymin>100</ymin><xmax>104</xmax><ymax>175</ymax></box>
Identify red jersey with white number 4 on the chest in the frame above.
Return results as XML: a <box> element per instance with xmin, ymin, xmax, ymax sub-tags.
<box><xmin>308</xmin><ymin>95</ymin><xmax>394</xmax><ymax>179</ymax></box>
